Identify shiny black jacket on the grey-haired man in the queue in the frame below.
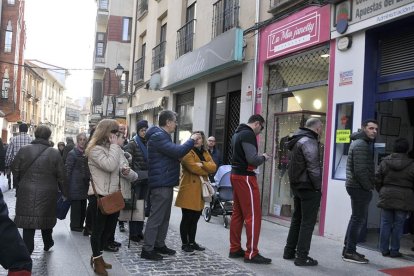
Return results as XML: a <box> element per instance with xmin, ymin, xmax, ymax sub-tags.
<box><xmin>287</xmin><ymin>127</ymin><xmax>322</xmax><ymax>190</ymax></box>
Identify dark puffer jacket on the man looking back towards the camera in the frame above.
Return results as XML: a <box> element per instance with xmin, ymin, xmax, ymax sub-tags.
<box><xmin>345</xmin><ymin>131</ymin><xmax>375</xmax><ymax>191</ymax></box>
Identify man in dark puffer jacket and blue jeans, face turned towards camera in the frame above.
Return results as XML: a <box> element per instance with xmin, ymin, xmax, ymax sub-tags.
<box><xmin>342</xmin><ymin>119</ymin><xmax>378</xmax><ymax>264</ymax></box>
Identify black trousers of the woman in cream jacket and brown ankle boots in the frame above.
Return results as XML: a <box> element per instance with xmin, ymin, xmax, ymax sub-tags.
<box><xmin>89</xmin><ymin>197</ymin><xmax>119</xmax><ymax>257</ymax></box>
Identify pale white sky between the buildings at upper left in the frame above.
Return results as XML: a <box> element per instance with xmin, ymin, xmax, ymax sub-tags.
<box><xmin>24</xmin><ymin>0</ymin><xmax>97</xmax><ymax>98</ymax></box>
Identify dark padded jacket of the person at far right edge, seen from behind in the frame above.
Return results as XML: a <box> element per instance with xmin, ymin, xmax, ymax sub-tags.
<box><xmin>375</xmin><ymin>153</ymin><xmax>414</xmax><ymax>211</ymax></box>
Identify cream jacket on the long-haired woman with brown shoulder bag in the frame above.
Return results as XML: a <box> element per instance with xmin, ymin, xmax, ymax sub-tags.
<box><xmin>88</xmin><ymin>144</ymin><xmax>124</xmax><ymax>196</ymax></box>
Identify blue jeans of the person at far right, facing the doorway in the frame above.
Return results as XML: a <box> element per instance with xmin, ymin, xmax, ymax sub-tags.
<box><xmin>380</xmin><ymin>209</ymin><xmax>408</xmax><ymax>255</ymax></box>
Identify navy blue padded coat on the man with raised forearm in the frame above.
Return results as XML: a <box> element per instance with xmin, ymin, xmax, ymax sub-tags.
<box><xmin>145</xmin><ymin>126</ymin><xmax>194</xmax><ymax>189</ymax></box>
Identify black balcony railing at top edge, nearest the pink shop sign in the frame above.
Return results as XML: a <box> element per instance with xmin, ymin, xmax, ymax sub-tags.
<box><xmin>212</xmin><ymin>0</ymin><xmax>240</xmax><ymax>38</ymax></box>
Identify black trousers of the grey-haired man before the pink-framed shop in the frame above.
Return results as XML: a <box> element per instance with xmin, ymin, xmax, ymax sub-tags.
<box><xmin>285</xmin><ymin>190</ymin><xmax>322</xmax><ymax>258</ymax></box>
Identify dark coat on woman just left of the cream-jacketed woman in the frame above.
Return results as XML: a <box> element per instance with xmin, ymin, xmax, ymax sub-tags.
<box><xmin>65</xmin><ymin>147</ymin><xmax>89</xmax><ymax>200</ymax></box>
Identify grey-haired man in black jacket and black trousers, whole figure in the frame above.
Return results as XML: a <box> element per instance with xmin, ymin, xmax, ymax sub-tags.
<box><xmin>283</xmin><ymin>118</ymin><xmax>323</xmax><ymax>266</ymax></box>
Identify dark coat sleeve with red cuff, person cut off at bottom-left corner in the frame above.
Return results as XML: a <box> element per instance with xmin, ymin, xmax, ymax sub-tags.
<box><xmin>0</xmin><ymin>190</ymin><xmax>32</xmax><ymax>271</ymax></box>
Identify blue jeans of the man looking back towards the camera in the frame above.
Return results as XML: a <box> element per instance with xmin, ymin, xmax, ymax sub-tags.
<box><xmin>345</xmin><ymin>187</ymin><xmax>372</xmax><ymax>253</ymax></box>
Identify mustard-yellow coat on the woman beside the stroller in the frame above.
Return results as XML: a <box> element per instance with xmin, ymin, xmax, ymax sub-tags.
<box><xmin>175</xmin><ymin>150</ymin><xmax>217</xmax><ymax>211</ymax></box>
